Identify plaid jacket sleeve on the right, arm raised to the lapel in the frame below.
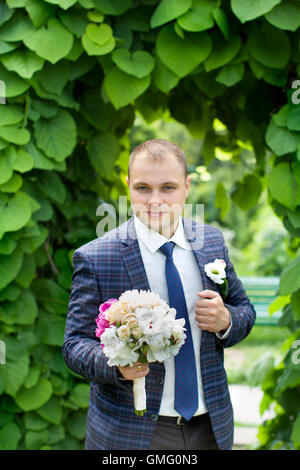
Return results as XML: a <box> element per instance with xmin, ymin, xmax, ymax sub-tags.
<box><xmin>218</xmin><ymin>234</ymin><xmax>256</xmax><ymax>348</ymax></box>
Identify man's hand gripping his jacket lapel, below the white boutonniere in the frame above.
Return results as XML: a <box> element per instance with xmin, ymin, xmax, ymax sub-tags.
<box><xmin>195</xmin><ymin>290</ymin><xmax>230</xmax><ymax>333</ymax></box>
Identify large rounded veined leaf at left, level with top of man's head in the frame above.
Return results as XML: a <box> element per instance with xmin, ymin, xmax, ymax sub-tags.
<box><xmin>34</xmin><ymin>110</ymin><xmax>77</xmax><ymax>162</ymax></box>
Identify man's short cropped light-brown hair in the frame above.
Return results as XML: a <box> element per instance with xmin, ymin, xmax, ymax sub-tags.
<box><xmin>128</xmin><ymin>139</ymin><xmax>188</xmax><ymax>178</ymax></box>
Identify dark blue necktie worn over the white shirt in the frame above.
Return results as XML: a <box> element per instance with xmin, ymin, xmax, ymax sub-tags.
<box><xmin>159</xmin><ymin>242</ymin><xmax>198</xmax><ymax>421</ymax></box>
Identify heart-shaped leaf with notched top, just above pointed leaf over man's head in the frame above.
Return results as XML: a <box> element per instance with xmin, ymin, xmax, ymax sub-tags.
<box><xmin>112</xmin><ymin>49</ymin><xmax>155</xmax><ymax>78</ymax></box>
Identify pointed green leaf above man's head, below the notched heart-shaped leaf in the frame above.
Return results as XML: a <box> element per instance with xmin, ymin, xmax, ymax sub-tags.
<box><xmin>104</xmin><ymin>67</ymin><xmax>151</xmax><ymax>109</ymax></box>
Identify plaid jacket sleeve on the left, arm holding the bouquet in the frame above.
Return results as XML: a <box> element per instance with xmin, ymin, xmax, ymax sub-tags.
<box><xmin>62</xmin><ymin>249</ymin><xmax>125</xmax><ymax>385</ymax></box>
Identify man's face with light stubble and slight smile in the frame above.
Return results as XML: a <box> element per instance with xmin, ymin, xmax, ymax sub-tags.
<box><xmin>126</xmin><ymin>153</ymin><xmax>191</xmax><ymax>238</ymax></box>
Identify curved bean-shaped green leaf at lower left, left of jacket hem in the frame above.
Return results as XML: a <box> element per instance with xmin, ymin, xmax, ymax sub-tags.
<box><xmin>15</xmin><ymin>378</ymin><xmax>52</xmax><ymax>411</ymax></box>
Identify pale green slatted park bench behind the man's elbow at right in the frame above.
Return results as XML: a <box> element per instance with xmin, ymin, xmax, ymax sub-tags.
<box><xmin>240</xmin><ymin>276</ymin><xmax>282</xmax><ymax>326</ymax></box>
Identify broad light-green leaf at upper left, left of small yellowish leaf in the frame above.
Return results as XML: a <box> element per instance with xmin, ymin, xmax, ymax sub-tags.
<box><xmin>24</xmin><ymin>18</ymin><xmax>73</xmax><ymax>64</ymax></box>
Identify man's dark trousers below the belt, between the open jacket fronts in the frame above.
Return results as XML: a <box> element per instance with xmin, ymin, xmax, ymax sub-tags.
<box><xmin>149</xmin><ymin>413</ymin><xmax>219</xmax><ymax>450</ymax></box>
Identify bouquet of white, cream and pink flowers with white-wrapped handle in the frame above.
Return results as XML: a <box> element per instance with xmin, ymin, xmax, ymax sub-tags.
<box><xmin>95</xmin><ymin>289</ymin><xmax>186</xmax><ymax>416</ymax></box>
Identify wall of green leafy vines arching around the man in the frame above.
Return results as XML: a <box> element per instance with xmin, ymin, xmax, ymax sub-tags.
<box><xmin>0</xmin><ymin>0</ymin><xmax>300</xmax><ymax>449</ymax></box>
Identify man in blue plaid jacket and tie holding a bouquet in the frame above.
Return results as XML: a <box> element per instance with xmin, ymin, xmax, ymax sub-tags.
<box><xmin>63</xmin><ymin>140</ymin><xmax>255</xmax><ymax>450</ymax></box>
